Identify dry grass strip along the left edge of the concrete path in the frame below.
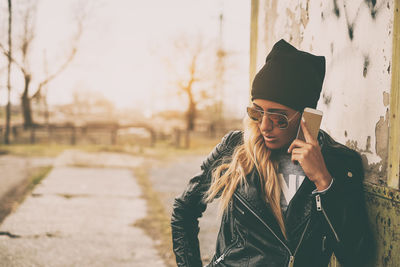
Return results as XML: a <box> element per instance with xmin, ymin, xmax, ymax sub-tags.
<box><xmin>0</xmin><ymin>166</ymin><xmax>52</xmax><ymax>223</ymax></box>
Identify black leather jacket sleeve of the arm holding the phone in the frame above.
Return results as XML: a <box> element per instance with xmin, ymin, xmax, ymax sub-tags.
<box><xmin>315</xmin><ymin>151</ymin><xmax>374</xmax><ymax>267</ymax></box>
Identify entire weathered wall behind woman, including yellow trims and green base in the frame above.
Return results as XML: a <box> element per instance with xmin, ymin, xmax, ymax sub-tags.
<box><xmin>250</xmin><ymin>0</ymin><xmax>400</xmax><ymax>266</ymax></box>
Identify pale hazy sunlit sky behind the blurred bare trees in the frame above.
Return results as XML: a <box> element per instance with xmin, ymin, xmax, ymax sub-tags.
<box><xmin>2</xmin><ymin>0</ymin><xmax>250</xmax><ymax>117</ymax></box>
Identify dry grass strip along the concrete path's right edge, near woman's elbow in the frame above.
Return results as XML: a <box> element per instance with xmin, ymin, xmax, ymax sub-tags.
<box><xmin>133</xmin><ymin>166</ymin><xmax>176</xmax><ymax>267</ymax></box>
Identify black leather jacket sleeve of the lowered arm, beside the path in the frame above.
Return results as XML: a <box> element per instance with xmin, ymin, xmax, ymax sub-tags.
<box><xmin>171</xmin><ymin>131</ymin><xmax>240</xmax><ymax>267</ymax></box>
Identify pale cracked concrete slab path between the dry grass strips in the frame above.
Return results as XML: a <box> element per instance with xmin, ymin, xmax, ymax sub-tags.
<box><xmin>0</xmin><ymin>151</ymin><xmax>164</xmax><ymax>267</ymax></box>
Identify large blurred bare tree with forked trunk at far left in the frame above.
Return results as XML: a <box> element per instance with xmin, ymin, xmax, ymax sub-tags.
<box><xmin>0</xmin><ymin>0</ymin><xmax>87</xmax><ymax>127</ymax></box>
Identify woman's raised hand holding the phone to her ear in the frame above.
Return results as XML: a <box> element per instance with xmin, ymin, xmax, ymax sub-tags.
<box><xmin>288</xmin><ymin>119</ymin><xmax>332</xmax><ymax>191</ymax></box>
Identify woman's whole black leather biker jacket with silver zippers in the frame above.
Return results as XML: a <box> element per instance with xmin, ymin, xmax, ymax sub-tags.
<box><xmin>171</xmin><ymin>130</ymin><xmax>373</xmax><ymax>267</ymax></box>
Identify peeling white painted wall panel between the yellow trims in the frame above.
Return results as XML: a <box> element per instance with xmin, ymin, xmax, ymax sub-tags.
<box><xmin>256</xmin><ymin>0</ymin><xmax>393</xmax><ymax>185</ymax></box>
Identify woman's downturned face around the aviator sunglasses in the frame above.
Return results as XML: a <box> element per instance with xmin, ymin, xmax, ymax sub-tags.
<box><xmin>253</xmin><ymin>99</ymin><xmax>301</xmax><ymax>152</ymax></box>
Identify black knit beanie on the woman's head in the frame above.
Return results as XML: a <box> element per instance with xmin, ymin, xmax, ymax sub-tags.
<box><xmin>251</xmin><ymin>39</ymin><xmax>325</xmax><ymax>111</ymax></box>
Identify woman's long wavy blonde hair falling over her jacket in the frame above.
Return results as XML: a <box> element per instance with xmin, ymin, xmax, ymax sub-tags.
<box><xmin>206</xmin><ymin>118</ymin><xmax>287</xmax><ymax>241</ymax></box>
